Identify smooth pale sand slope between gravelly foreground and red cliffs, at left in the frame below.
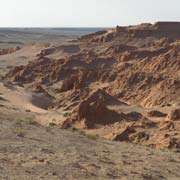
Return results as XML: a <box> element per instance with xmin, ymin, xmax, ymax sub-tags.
<box><xmin>0</xmin><ymin>82</ymin><xmax>64</xmax><ymax>126</ymax></box>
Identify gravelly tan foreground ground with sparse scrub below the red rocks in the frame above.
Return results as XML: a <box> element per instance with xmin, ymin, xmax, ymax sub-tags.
<box><xmin>0</xmin><ymin>108</ymin><xmax>180</xmax><ymax>180</ymax></box>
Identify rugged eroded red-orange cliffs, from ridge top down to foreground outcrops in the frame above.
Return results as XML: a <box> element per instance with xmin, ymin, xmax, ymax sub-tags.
<box><xmin>4</xmin><ymin>22</ymin><xmax>180</xmax><ymax>149</ymax></box>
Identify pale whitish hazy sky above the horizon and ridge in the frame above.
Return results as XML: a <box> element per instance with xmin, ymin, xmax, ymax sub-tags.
<box><xmin>0</xmin><ymin>0</ymin><xmax>180</xmax><ymax>27</ymax></box>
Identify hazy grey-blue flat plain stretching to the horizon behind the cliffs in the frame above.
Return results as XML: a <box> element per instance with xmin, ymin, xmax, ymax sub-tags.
<box><xmin>0</xmin><ymin>28</ymin><xmax>107</xmax><ymax>48</ymax></box>
